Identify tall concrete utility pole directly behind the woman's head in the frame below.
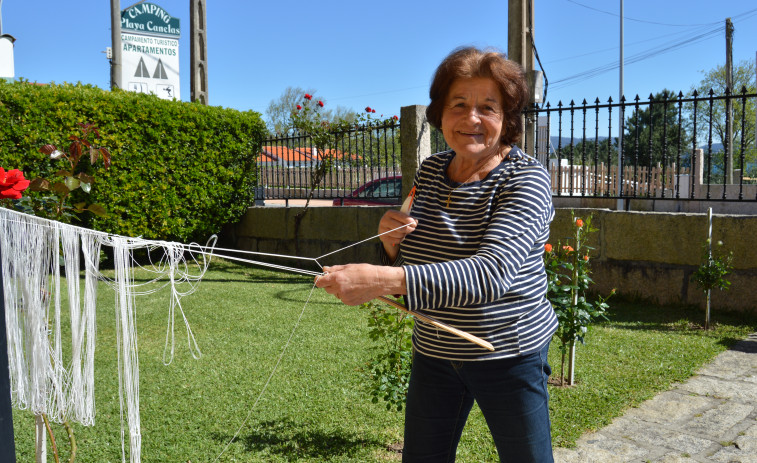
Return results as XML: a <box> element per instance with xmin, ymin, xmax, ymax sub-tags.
<box><xmin>507</xmin><ymin>0</ymin><xmax>536</xmax><ymax>157</ymax></box>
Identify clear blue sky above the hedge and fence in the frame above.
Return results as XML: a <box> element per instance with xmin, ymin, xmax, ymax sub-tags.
<box><xmin>2</xmin><ymin>0</ymin><xmax>757</xmax><ymax>123</ymax></box>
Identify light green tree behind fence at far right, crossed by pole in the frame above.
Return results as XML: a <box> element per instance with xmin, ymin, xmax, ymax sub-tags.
<box><xmin>687</xmin><ymin>60</ymin><xmax>757</xmax><ymax>179</ymax></box>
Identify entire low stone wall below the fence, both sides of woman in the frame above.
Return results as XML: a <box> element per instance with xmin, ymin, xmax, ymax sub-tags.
<box><xmin>223</xmin><ymin>207</ymin><xmax>757</xmax><ymax>312</ymax></box>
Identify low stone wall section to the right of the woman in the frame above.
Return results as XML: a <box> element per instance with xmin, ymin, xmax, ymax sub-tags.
<box><xmin>550</xmin><ymin>209</ymin><xmax>757</xmax><ymax>312</ymax></box>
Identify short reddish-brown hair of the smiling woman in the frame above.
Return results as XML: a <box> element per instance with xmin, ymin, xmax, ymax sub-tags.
<box><xmin>426</xmin><ymin>47</ymin><xmax>530</xmax><ymax>146</ymax></box>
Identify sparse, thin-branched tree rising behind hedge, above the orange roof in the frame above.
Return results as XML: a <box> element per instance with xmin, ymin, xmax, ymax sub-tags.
<box><xmin>265</xmin><ymin>87</ymin><xmax>357</xmax><ymax>134</ymax></box>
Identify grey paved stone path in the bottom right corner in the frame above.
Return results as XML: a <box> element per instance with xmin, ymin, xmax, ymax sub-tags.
<box><xmin>555</xmin><ymin>333</ymin><xmax>757</xmax><ymax>463</ymax></box>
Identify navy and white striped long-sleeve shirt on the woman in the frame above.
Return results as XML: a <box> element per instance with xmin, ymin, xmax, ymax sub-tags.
<box><xmin>395</xmin><ymin>147</ymin><xmax>557</xmax><ymax>360</ymax></box>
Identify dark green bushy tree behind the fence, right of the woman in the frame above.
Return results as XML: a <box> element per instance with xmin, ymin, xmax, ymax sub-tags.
<box><xmin>623</xmin><ymin>89</ymin><xmax>691</xmax><ymax>167</ymax></box>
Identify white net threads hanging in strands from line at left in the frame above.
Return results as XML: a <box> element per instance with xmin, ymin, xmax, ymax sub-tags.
<box><xmin>0</xmin><ymin>208</ymin><xmax>216</xmax><ymax>462</ymax></box>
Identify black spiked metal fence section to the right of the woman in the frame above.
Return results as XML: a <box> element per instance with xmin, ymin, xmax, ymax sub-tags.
<box><xmin>523</xmin><ymin>89</ymin><xmax>757</xmax><ymax>201</ymax></box>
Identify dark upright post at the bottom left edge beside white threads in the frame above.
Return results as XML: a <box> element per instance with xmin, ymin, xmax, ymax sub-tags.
<box><xmin>0</xmin><ymin>245</ymin><xmax>16</xmax><ymax>463</ymax></box>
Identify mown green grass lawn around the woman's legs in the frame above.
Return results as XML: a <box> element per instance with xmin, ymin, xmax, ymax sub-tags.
<box><xmin>13</xmin><ymin>260</ymin><xmax>757</xmax><ymax>463</ymax></box>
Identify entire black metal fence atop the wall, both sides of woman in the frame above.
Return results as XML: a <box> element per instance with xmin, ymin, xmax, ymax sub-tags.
<box><xmin>258</xmin><ymin>89</ymin><xmax>757</xmax><ymax>205</ymax></box>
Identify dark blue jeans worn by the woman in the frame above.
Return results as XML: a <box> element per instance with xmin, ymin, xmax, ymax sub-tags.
<box><xmin>402</xmin><ymin>344</ymin><xmax>554</xmax><ymax>463</ymax></box>
